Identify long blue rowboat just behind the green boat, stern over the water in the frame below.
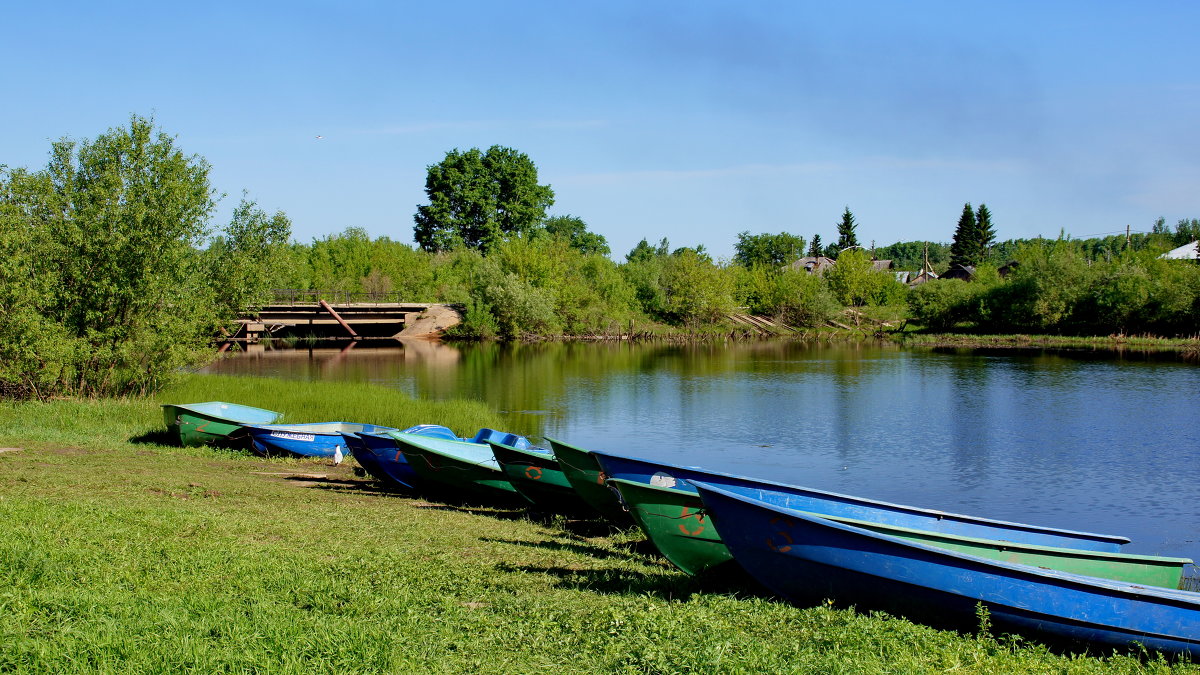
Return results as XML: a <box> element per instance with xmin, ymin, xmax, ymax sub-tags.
<box><xmin>592</xmin><ymin>450</ymin><xmax>1129</xmax><ymax>552</ymax></box>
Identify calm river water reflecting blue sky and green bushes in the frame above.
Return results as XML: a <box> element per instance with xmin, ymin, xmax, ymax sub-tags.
<box><xmin>206</xmin><ymin>342</ymin><xmax>1200</xmax><ymax>560</ymax></box>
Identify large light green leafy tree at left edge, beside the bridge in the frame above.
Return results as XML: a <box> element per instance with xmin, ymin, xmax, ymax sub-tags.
<box><xmin>0</xmin><ymin>115</ymin><xmax>220</xmax><ymax>396</ymax></box>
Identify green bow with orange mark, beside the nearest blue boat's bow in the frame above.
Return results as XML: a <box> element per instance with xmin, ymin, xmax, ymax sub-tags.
<box><xmin>608</xmin><ymin>478</ymin><xmax>733</xmax><ymax>575</ymax></box>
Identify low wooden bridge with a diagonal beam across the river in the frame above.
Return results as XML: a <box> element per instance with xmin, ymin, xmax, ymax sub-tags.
<box><xmin>221</xmin><ymin>289</ymin><xmax>458</xmax><ymax>351</ymax></box>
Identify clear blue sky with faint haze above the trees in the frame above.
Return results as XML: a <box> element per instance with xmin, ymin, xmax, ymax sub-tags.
<box><xmin>0</xmin><ymin>0</ymin><xmax>1200</xmax><ymax>258</ymax></box>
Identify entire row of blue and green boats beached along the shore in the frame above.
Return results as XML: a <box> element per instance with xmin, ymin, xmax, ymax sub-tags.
<box><xmin>163</xmin><ymin>402</ymin><xmax>1200</xmax><ymax>658</ymax></box>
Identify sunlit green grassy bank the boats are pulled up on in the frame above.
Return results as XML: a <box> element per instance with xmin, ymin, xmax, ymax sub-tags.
<box><xmin>0</xmin><ymin>377</ymin><xmax>1200</xmax><ymax>673</ymax></box>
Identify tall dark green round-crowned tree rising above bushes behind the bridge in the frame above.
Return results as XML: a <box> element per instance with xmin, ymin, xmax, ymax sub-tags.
<box><xmin>413</xmin><ymin>145</ymin><xmax>554</xmax><ymax>252</ymax></box>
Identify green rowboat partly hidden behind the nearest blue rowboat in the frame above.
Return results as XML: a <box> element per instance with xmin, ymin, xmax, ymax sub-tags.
<box><xmin>608</xmin><ymin>479</ymin><xmax>1192</xmax><ymax>589</ymax></box>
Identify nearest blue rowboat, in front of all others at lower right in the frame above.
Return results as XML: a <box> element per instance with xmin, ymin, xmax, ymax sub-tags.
<box><xmin>692</xmin><ymin>480</ymin><xmax>1200</xmax><ymax>658</ymax></box>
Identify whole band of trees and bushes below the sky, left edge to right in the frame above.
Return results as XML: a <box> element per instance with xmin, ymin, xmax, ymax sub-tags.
<box><xmin>0</xmin><ymin>115</ymin><xmax>1200</xmax><ymax>398</ymax></box>
